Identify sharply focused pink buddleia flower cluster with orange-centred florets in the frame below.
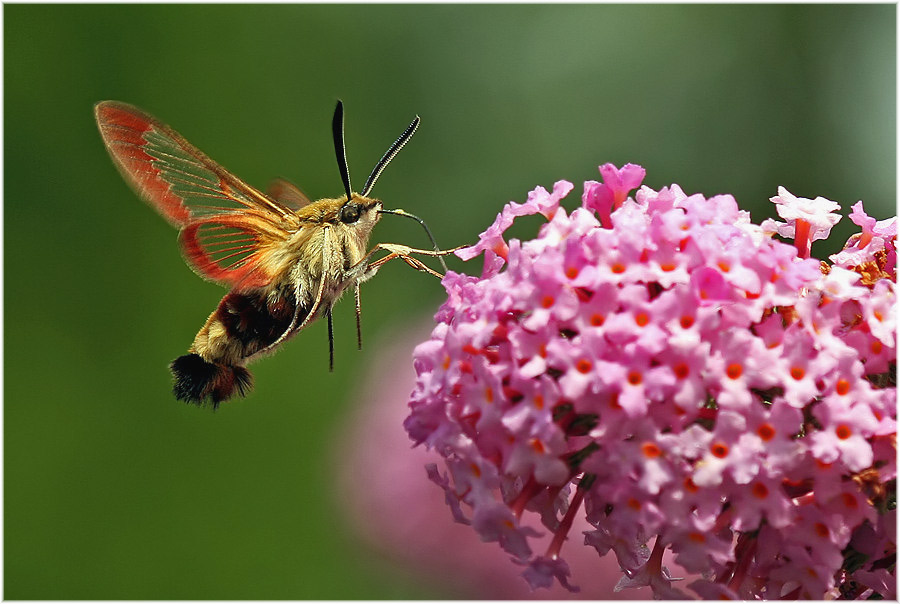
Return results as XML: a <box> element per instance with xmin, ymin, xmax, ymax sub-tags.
<box><xmin>405</xmin><ymin>164</ymin><xmax>896</xmax><ymax>599</ymax></box>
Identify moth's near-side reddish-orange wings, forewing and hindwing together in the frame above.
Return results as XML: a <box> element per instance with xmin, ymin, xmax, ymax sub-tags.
<box><xmin>95</xmin><ymin>101</ymin><xmax>299</xmax><ymax>288</ymax></box>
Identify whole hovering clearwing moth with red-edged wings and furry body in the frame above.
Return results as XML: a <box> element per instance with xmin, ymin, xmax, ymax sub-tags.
<box><xmin>94</xmin><ymin>101</ymin><xmax>453</xmax><ymax>408</ymax></box>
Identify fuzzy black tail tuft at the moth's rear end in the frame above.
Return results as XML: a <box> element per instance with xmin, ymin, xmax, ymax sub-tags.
<box><xmin>170</xmin><ymin>354</ymin><xmax>253</xmax><ymax>409</ymax></box>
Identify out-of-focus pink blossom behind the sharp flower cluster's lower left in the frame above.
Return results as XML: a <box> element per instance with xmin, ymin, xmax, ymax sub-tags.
<box><xmin>332</xmin><ymin>318</ymin><xmax>650</xmax><ymax>600</ymax></box>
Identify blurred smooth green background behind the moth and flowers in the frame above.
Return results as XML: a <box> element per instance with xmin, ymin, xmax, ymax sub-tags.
<box><xmin>3</xmin><ymin>4</ymin><xmax>896</xmax><ymax>599</ymax></box>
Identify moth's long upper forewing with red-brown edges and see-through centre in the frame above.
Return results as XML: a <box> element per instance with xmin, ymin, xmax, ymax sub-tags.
<box><xmin>94</xmin><ymin>101</ymin><xmax>292</xmax><ymax>227</ymax></box>
